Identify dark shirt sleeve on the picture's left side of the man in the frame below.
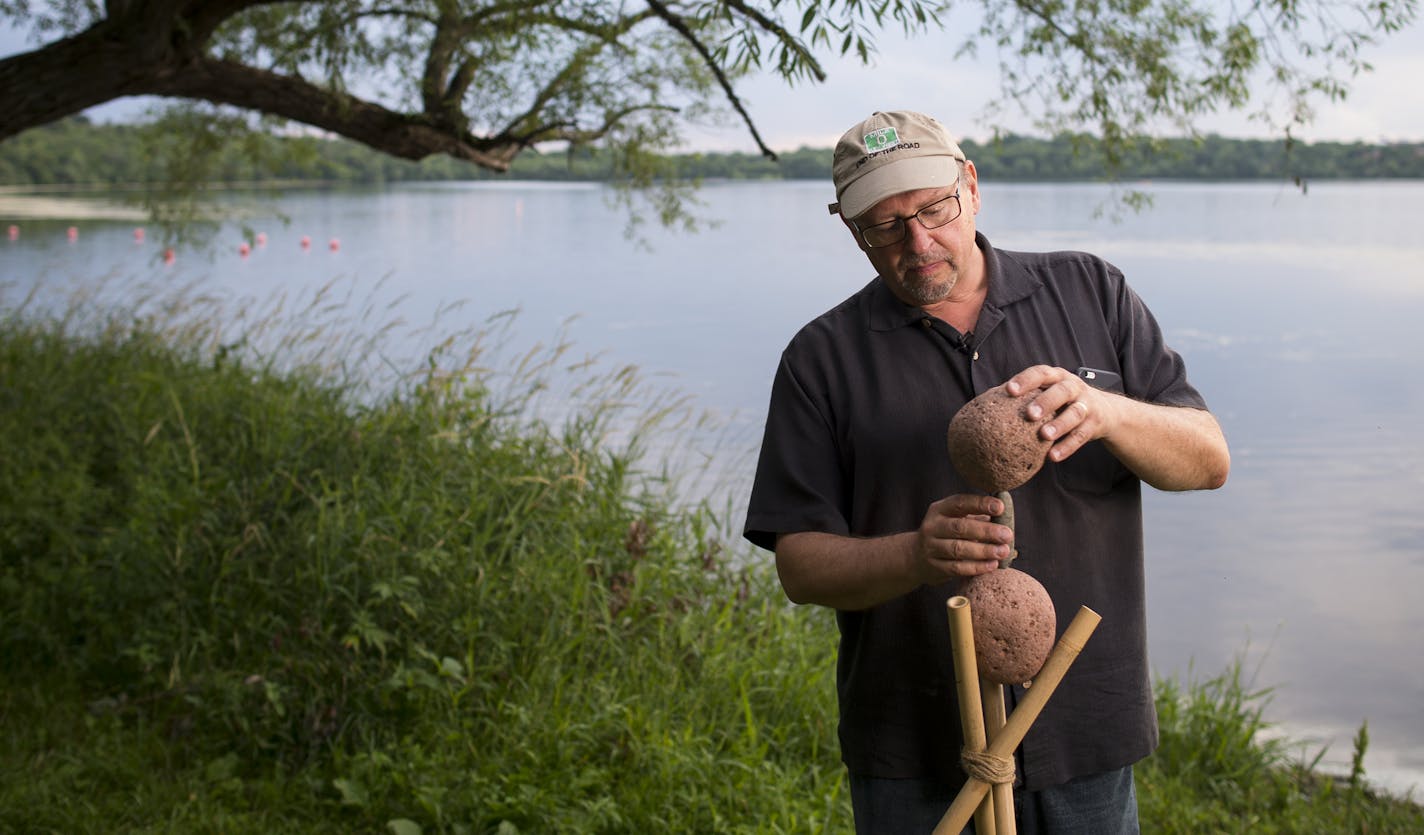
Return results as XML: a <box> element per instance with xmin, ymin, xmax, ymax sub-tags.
<box><xmin>743</xmin><ymin>348</ymin><xmax>849</xmax><ymax>550</ymax></box>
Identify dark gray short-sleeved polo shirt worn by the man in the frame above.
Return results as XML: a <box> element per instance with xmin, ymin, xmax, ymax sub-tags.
<box><xmin>745</xmin><ymin>235</ymin><xmax>1205</xmax><ymax>789</ymax></box>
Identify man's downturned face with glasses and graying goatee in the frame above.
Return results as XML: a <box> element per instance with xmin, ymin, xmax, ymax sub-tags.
<box><xmin>847</xmin><ymin>162</ymin><xmax>980</xmax><ymax>306</ymax></box>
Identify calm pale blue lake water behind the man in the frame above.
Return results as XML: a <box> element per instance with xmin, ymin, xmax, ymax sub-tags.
<box><xmin>0</xmin><ymin>182</ymin><xmax>1424</xmax><ymax>794</ymax></box>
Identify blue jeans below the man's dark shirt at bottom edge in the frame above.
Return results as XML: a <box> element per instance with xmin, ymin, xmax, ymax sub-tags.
<box><xmin>850</xmin><ymin>765</ymin><xmax>1139</xmax><ymax>835</ymax></box>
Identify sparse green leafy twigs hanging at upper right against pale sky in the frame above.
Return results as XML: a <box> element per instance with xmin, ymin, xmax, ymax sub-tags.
<box><xmin>979</xmin><ymin>0</ymin><xmax>1418</xmax><ymax>159</ymax></box>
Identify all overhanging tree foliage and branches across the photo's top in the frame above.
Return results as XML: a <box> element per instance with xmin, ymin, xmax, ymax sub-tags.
<box><xmin>0</xmin><ymin>0</ymin><xmax>1418</xmax><ymax>198</ymax></box>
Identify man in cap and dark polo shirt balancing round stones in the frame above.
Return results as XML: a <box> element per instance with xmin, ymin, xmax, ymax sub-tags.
<box><xmin>746</xmin><ymin>111</ymin><xmax>1230</xmax><ymax>835</ymax></box>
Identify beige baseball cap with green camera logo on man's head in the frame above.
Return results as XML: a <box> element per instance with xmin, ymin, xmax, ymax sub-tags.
<box><xmin>829</xmin><ymin>110</ymin><xmax>964</xmax><ymax>218</ymax></box>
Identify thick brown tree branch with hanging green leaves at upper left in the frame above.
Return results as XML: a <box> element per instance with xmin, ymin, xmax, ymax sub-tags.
<box><xmin>0</xmin><ymin>0</ymin><xmax>946</xmax><ymax>188</ymax></box>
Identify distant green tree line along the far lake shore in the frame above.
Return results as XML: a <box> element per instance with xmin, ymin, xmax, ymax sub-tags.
<box><xmin>0</xmin><ymin>117</ymin><xmax>1424</xmax><ymax>187</ymax></box>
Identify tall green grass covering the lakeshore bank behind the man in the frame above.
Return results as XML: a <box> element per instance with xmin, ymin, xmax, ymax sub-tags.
<box><xmin>0</xmin><ymin>282</ymin><xmax>1424</xmax><ymax>835</ymax></box>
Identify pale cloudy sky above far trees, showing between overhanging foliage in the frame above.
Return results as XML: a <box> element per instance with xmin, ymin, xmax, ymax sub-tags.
<box><xmin>0</xmin><ymin>10</ymin><xmax>1424</xmax><ymax>152</ymax></box>
